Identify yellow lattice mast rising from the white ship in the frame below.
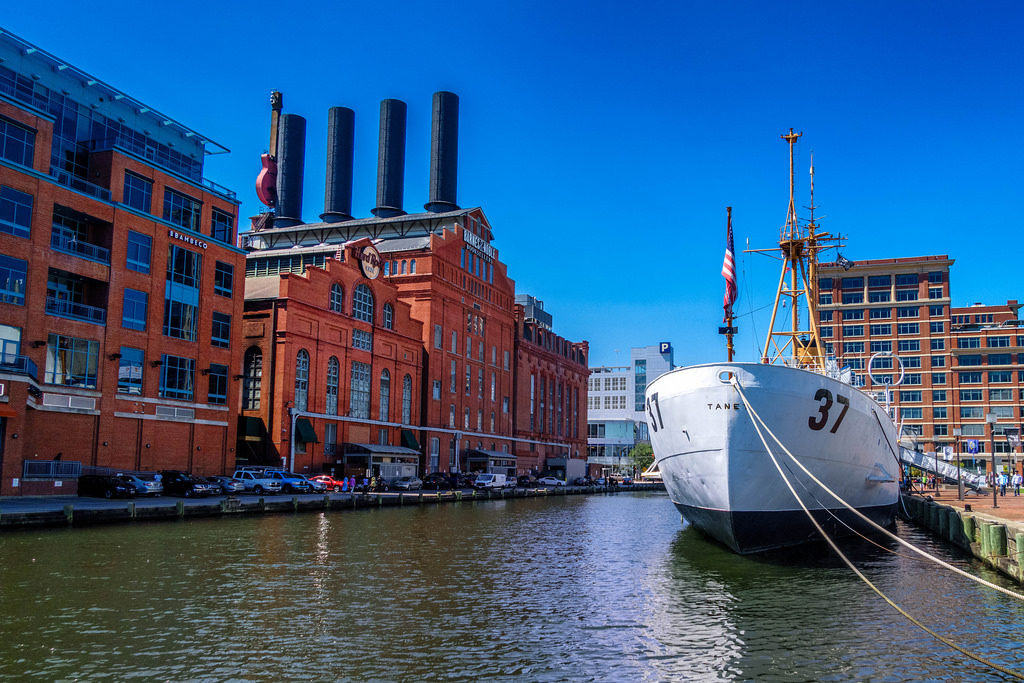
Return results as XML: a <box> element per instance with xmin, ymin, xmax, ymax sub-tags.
<box><xmin>761</xmin><ymin>128</ymin><xmax>837</xmax><ymax>371</ymax></box>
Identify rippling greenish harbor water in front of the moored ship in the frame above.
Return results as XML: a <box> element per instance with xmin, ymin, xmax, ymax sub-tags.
<box><xmin>0</xmin><ymin>494</ymin><xmax>1024</xmax><ymax>681</ymax></box>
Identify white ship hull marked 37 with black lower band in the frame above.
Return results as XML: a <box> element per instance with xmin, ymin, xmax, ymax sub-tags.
<box><xmin>646</xmin><ymin>362</ymin><xmax>899</xmax><ymax>553</ymax></box>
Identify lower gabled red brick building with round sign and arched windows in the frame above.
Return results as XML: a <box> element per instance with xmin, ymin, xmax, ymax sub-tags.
<box><xmin>238</xmin><ymin>238</ymin><xmax>423</xmax><ymax>476</ymax></box>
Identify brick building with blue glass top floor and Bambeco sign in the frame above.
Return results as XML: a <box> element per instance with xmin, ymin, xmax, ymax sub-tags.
<box><xmin>0</xmin><ymin>33</ymin><xmax>245</xmax><ymax>495</ymax></box>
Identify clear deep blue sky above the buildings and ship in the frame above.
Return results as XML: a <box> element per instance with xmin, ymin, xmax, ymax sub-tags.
<box><xmin>8</xmin><ymin>0</ymin><xmax>1024</xmax><ymax>365</ymax></box>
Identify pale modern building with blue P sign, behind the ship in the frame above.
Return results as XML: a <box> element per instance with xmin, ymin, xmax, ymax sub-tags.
<box><xmin>587</xmin><ymin>342</ymin><xmax>675</xmax><ymax>475</ymax></box>
